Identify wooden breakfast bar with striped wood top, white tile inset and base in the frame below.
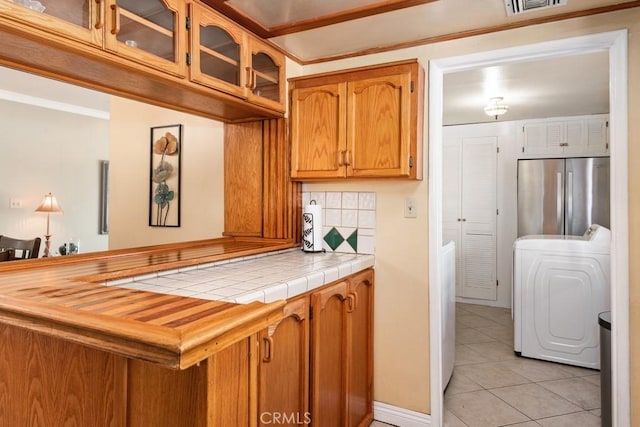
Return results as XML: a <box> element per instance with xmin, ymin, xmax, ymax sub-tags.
<box><xmin>0</xmin><ymin>237</ymin><xmax>373</xmax><ymax>427</ymax></box>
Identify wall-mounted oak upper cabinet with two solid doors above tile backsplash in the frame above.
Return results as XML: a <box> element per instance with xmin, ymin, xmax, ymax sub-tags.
<box><xmin>289</xmin><ymin>60</ymin><xmax>424</xmax><ymax>180</ymax></box>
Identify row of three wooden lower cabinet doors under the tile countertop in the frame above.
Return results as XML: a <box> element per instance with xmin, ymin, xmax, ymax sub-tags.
<box><xmin>255</xmin><ymin>269</ymin><xmax>373</xmax><ymax>427</ymax></box>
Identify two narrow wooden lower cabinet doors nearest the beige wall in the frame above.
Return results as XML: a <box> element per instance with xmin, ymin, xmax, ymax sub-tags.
<box><xmin>311</xmin><ymin>270</ymin><xmax>373</xmax><ymax>427</ymax></box>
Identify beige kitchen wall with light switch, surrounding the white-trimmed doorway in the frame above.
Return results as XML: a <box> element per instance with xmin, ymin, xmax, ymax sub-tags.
<box><xmin>290</xmin><ymin>8</ymin><xmax>640</xmax><ymax>416</ymax></box>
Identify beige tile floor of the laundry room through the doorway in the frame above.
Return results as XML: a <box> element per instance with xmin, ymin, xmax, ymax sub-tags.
<box><xmin>442</xmin><ymin>303</ymin><xmax>600</xmax><ymax>427</ymax></box>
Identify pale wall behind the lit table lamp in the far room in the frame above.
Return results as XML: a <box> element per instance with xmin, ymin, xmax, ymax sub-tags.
<box><xmin>0</xmin><ymin>100</ymin><xmax>109</xmax><ymax>256</ymax></box>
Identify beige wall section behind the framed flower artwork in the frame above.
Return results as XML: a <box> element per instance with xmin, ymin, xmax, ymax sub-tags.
<box><xmin>109</xmin><ymin>96</ymin><xmax>224</xmax><ymax>249</ymax></box>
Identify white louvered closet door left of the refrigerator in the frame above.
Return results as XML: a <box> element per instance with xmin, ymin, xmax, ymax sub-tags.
<box><xmin>460</xmin><ymin>137</ymin><xmax>497</xmax><ymax>301</ymax></box>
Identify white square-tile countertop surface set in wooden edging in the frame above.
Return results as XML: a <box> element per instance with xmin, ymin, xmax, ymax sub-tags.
<box><xmin>106</xmin><ymin>249</ymin><xmax>374</xmax><ymax>304</ymax></box>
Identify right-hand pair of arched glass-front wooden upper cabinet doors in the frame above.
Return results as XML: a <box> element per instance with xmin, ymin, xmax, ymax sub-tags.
<box><xmin>190</xmin><ymin>3</ymin><xmax>285</xmax><ymax>111</ymax></box>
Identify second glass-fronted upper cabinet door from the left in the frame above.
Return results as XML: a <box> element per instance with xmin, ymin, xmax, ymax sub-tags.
<box><xmin>106</xmin><ymin>0</ymin><xmax>186</xmax><ymax>76</ymax></box>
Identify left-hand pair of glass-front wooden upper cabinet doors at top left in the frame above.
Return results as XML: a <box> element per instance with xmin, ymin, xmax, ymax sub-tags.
<box><xmin>0</xmin><ymin>0</ymin><xmax>186</xmax><ymax>77</ymax></box>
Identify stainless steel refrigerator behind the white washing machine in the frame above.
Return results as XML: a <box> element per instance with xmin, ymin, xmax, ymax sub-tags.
<box><xmin>518</xmin><ymin>157</ymin><xmax>610</xmax><ymax>237</ymax></box>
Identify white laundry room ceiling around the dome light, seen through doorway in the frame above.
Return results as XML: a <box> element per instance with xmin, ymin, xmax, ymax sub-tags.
<box><xmin>443</xmin><ymin>51</ymin><xmax>609</xmax><ymax>125</ymax></box>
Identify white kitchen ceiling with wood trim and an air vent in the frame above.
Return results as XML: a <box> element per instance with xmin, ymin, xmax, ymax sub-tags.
<box><xmin>256</xmin><ymin>0</ymin><xmax>633</xmax><ymax>62</ymax></box>
